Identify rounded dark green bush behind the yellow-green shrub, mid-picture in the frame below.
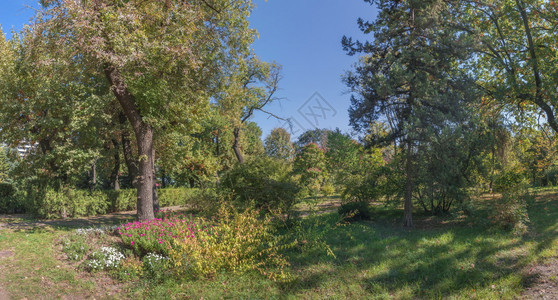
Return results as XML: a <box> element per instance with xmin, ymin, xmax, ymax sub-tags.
<box><xmin>219</xmin><ymin>157</ymin><xmax>298</xmax><ymax>213</ymax></box>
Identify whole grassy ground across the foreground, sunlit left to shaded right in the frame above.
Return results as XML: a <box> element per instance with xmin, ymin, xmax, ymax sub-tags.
<box><xmin>0</xmin><ymin>189</ymin><xmax>558</xmax><ymax>299</ymax></box>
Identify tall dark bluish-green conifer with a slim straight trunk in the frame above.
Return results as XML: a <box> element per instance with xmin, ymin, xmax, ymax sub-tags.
<box><xmin>342</xmin><ymin>0</ymin><xmax>480</xmax><ymax>227</ymax></box>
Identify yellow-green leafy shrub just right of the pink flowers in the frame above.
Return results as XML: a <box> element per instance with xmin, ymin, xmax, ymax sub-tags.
<box><xmin>171</xmin><ymin>206</ymin><xmax>288</xmax><ymax>280</ymax></box>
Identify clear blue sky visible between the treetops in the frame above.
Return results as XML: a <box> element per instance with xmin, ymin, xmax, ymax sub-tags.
<box><xmin>0</xmin><ymin>0</ymin><xmax>376</xmax><ymax>141</ymax></box>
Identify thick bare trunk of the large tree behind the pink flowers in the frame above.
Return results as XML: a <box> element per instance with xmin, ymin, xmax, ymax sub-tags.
<box><xmin>104</xmin><ymin>64</ymin><xmax>155</xmax><ymax>221</ymax></box>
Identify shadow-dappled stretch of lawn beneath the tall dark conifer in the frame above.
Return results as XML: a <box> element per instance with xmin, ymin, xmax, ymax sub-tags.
<box><xmin>282</xmin><ymin>192</ymin><xmax>558</xmax><ymax>298</ymax></box>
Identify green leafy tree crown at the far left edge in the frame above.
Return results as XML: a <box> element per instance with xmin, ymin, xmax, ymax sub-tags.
<box><xmin>0</xmin><ymin>27</ymin><xmax>109</xmax><ymax>188</ymax></box>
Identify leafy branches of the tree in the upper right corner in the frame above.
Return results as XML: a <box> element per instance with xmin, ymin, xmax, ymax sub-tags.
<box><xmin>464</xmin><ymin>0</ymin><xmax>558</xmax><ymax>132</ymax></box>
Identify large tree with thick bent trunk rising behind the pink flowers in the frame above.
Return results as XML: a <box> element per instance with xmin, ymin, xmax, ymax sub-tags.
<box><xmin>34</xmin><ymin>0</ymin><xmax>262</xmax><ymax>221</ymax></box>
